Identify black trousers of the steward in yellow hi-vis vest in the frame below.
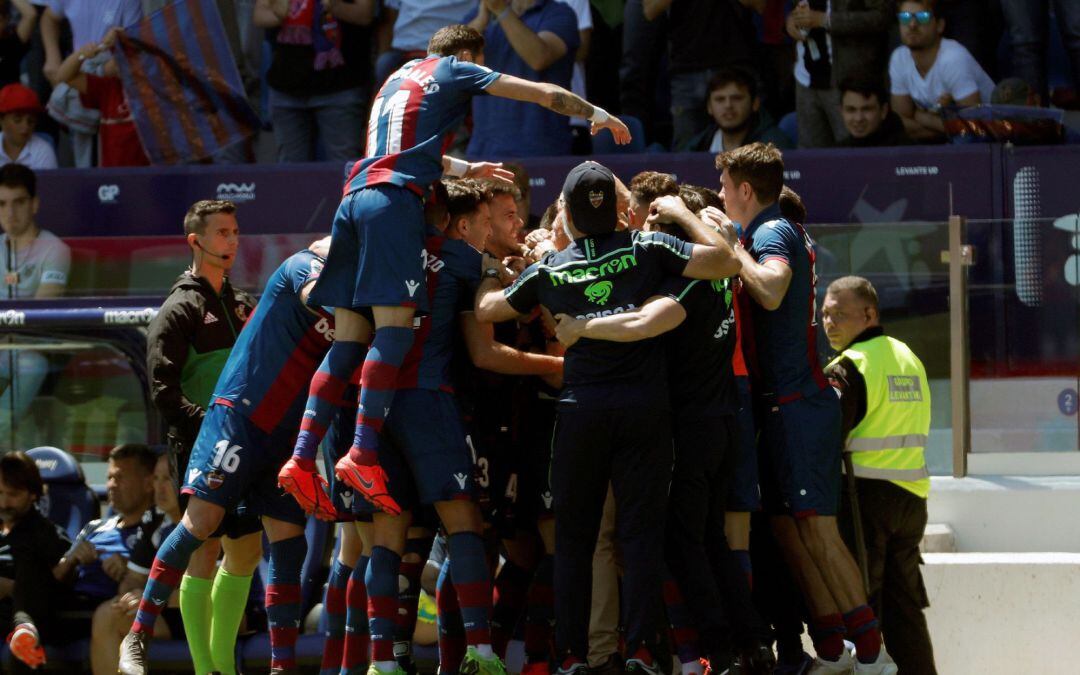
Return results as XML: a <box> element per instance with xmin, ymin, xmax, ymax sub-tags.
<box><xmin>840</xmin><ymin>478</ymin><xmax>937</xmax><ymax>675</ymax></box>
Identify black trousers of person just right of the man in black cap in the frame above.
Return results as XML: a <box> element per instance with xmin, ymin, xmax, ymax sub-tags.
<box><xmin>664</xmin><ymin>414</ymin><xmax>769</xmax><ymax>659</ymax></box>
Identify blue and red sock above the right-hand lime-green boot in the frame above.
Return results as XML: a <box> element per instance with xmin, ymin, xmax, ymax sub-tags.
<box><xmin>446</xmin><ymin>532</ymin><xmax>491</xmax><ymax>645</ymax></box>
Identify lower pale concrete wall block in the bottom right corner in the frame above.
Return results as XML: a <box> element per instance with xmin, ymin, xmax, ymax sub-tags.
<box><xmin>922</xmin><ymin>553</ymin><xmax>1080</xmax><ymax>675</ymax></box>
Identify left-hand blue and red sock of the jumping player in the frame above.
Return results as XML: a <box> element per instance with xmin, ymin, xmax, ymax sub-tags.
<box><xmin>293</xmin><ymin>341</ymin><xmax>367</xmax><ymax>461</ymax></box>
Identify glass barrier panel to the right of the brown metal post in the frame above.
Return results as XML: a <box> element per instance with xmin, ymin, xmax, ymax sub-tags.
<box><xmin>967</xmin><ymin>213</ymin><xmax>1080</xmax><ymax>453</ymax></box>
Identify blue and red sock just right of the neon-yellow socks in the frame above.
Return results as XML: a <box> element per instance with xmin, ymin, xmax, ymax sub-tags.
<box><xmin>267</xmin><ymin>535</ymin><xmax>308</xmax><ymax>669</ymax></box>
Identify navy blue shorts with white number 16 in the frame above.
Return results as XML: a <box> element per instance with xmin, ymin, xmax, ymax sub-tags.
<box><xmin>183</xmin><ymin>403</ymin><xmax>308</xmax><ymax>526</ymax></box>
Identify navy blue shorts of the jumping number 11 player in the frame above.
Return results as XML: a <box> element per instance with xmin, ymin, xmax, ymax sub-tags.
<box><xmin>309</xmin><ymin>185</ymin><xmax>428</xmax><ymax>312</ymax></box>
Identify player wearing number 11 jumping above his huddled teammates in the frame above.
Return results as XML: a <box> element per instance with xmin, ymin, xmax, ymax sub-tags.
<box><xmin>280</xmin><ymin>25</ymin><xmax>630</xmax><ymax>517</ymax></box>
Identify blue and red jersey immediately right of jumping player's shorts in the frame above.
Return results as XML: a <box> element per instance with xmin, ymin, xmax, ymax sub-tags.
<box><xmin>397</xmin><ymin>228</ymin><xmax>482</xmax><ymax>391</ymax></box>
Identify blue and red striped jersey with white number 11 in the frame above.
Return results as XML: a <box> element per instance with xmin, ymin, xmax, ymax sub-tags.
<box><xmin>345</xmin><ymin>56</ymin><xmax>499</xmax><ymax>194</ymax></box>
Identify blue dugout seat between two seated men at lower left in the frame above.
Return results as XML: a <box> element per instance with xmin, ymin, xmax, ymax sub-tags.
<box><xmin>26</xmin><ymin>446</ymin><xmax>100</xmax><ymax>540</ymax></box>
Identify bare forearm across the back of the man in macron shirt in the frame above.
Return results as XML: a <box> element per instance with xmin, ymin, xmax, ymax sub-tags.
<box><xmin>555</xmin><ymin>295</ymin><xmax>686</xmax><ymax>347</ymax></box>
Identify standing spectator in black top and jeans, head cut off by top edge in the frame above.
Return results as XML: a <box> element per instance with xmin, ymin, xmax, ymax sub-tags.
<box><xmin>643</xmin><ymin>0</ymin><xmax>760</xmax><ymax>148</ymax></box>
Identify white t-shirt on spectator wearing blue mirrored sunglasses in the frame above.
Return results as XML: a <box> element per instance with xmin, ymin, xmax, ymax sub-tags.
<box><xmin>889</xmin><ymin>38</ymin><xmax>994</xmax><ymax>110</ymax></box>
